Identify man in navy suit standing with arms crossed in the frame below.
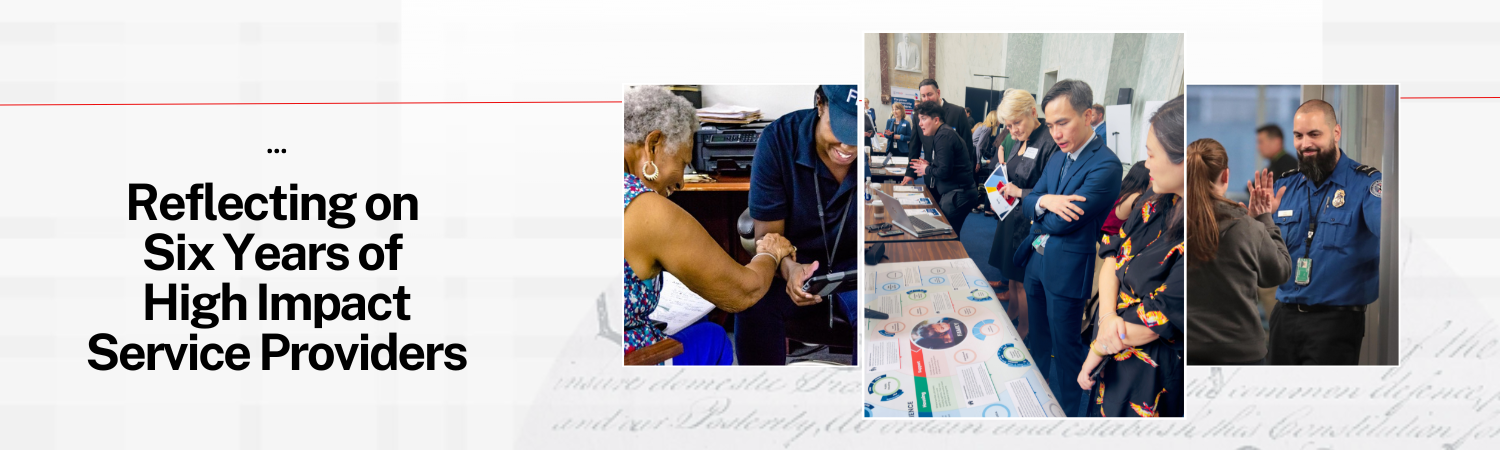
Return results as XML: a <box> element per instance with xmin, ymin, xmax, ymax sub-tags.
<box><xmin>1016</xmin><ymin>80</ymin><xmax>1122</xmax><ymax>416</ymax></box>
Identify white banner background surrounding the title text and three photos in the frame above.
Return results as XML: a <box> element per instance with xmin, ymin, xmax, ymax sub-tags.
<box><xmin>0</xmin><ymin>2</ymin><xmax>1500</xmax><ymax>449</ymax></box>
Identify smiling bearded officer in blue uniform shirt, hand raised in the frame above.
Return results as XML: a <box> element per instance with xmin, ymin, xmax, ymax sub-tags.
<box><xmin>1251</xmin><ymin>99</ymin><xmax>1382</xmax><ymax>365</ymax></box>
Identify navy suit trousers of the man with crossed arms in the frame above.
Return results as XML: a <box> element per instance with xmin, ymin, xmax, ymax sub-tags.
<box><xmin>1026</xmin><ymin>254</ymin><xmax>1089</xmax><ymax>417</ymax></box>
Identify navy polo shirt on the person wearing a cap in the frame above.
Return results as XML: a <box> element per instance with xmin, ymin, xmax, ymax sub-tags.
<box><xmin>750</xmin><ymin>110</ymin><xmax>860</xmax><ymax>273</ymax></box>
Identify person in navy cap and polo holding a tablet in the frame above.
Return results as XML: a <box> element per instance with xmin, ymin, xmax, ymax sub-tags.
<box><xmin>735</xmin><ymin>84</ymin><xmax>861</xmax><ymax>366</ymax></box>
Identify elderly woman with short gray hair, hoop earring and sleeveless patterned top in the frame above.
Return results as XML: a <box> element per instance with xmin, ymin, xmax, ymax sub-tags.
<box><xmin>624</xmin><ymin>86</ymin><xmax>795</xmax><ymax>366</ymax></box>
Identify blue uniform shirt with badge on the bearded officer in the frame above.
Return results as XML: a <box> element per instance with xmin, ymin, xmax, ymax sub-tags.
<box><xmin>1272</xmin><ymin>152</ymin><xmax>1382</xmax><ymax>306</ymax></box>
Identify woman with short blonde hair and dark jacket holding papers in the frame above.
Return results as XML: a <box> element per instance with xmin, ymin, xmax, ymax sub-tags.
<box><xmin>990</xmin><ymin>89</ymin><xmax>1059</xmax><ymax>338</ymax></box>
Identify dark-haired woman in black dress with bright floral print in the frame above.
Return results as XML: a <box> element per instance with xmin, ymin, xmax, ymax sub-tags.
<box><xmin>1079</xmin><ymin>96</ymin><xmax>1187</xmax><ymax>417</ymax></box>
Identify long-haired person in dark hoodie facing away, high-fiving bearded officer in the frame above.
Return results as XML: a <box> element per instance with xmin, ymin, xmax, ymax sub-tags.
<box><xmin>1188</xmin><ymin>140</ymin><xmax>1292</xmax><ymax>366</ymax></box>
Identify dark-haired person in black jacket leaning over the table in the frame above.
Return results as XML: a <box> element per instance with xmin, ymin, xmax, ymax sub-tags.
<box><xmin>912</xmin><ymin>102</ymin><xmax>980</xmax><ymax>236</ymax></box>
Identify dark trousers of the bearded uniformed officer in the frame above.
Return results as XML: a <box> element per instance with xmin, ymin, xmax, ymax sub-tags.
<box><xmin>1268</xmin><ymin>303</ymin><xmax>1365</xmax><ymax>366</ymax></box>
